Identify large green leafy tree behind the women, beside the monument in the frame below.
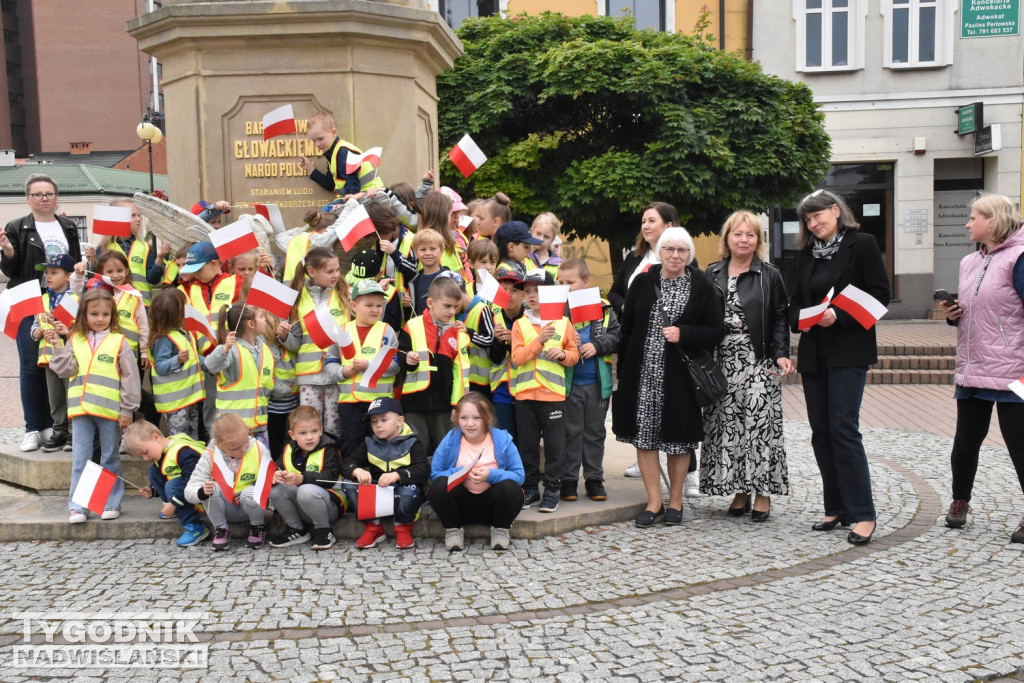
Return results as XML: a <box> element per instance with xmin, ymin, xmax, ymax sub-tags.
<box><xmin>437</xmin><ymin>12</ymin><xmax>829</xmax><ymax>252</ymax></box>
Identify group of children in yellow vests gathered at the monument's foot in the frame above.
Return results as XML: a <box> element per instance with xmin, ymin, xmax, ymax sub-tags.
<box><xmin>33</xmin><ymin>120</ymin><xmax>618</xmax><ymax>550</ymax></box>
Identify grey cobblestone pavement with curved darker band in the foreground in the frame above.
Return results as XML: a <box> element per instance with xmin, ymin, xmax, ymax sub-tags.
<box><xmin>0</xmin><ymin>422</ymin><xmax>1024</xmax><ymax>681</ymax></box>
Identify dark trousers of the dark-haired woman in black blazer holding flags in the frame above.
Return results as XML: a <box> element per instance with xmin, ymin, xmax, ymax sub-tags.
<box><xmin>801</xmin><ymin>364</ymin><xmax>876</xmax><ymax>523</ymax></box>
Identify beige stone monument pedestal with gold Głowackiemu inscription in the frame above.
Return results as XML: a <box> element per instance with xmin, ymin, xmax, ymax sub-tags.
<box><xmin>128</xmin><ymin>0</ymin><xmax>462</xmax><ymax>226</ymax></box>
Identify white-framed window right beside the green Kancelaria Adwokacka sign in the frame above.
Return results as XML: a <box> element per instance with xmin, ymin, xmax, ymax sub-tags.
<box><xmin>882</xmin><ymin>0</ymin><xmax>956</xmax><ymax>69</ymax></box>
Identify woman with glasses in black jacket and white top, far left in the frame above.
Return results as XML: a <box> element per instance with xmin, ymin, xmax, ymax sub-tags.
<box><xmin>0</xmin><ymin>174</ymin><xmax>82</xmax><ymax>453</ymax></box>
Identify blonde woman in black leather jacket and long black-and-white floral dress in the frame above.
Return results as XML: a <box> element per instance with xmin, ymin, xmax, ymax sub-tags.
<box><xmin>700</xmin><ymin>211</ymin><xmax>793</xmax><ymax>522</ymax></box>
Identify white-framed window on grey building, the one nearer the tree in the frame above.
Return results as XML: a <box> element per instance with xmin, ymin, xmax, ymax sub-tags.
<box><xmin>793</xmin><ymin>0</ymin><xmax>867</xmax><ymax>72</ymax></box>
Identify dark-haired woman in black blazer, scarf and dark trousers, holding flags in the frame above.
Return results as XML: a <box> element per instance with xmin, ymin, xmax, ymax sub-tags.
<box><xmin>790</xmin><ymin>189</ymin><xmax>890</xmax><ymax>545</ymax></box>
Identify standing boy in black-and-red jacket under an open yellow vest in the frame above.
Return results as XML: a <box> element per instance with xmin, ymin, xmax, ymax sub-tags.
<box><xmin>398</xmin><ymin>271</ymin><xmax>470</xmax><ymax>453</ymax></box>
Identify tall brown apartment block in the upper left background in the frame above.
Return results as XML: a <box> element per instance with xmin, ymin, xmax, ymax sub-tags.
<box><xmin>0</xmin><ymin>0</ymin><xmax>157</xmax><ymax>157</ymax></box>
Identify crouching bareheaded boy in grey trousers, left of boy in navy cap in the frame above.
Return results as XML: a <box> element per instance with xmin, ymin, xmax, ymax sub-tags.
<box><xmin>270</xmin><ymin>405</ymin><xmax>345</xmax><ymax>550</ymax></box>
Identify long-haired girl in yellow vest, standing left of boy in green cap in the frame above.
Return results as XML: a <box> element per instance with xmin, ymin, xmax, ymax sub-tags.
<box><xmin>282</xmin><ymin>247</ymin><xmax>350</xmax><ymax>440</ymax></box>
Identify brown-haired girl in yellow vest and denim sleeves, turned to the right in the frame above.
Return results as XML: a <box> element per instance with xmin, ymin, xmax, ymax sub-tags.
<box><xmin>146</xmin><ymin>290</ymin><xmax>206</xmax><ymax>439</ymax></box>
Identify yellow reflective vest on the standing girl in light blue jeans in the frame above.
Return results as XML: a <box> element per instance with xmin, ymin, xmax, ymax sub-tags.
<box><xmin>68</xmin><ymin>332</ymin><xmax>125</xmax><ymax>420</ymax></box>
